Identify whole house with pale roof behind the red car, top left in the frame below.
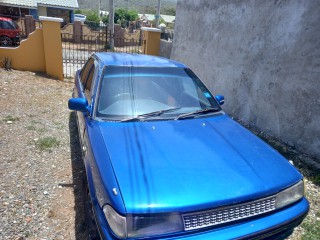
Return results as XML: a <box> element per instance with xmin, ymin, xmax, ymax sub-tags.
<box><xmin>0</xmin><ymin>0</ymin><xmax>79</xmax><ymax>23</ymax></box>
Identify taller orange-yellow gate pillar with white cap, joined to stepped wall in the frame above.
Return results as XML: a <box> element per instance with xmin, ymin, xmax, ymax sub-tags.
<box><xmin>39</xmin><ymin>16</ymin><xmax>63</xmax><ymax>80</ymax></box>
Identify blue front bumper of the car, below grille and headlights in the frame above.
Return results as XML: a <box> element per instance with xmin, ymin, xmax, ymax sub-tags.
<box><xmin>96</xmin><ymin>198</ymin><xmax>309</xmax><ymax>240</ymax></box>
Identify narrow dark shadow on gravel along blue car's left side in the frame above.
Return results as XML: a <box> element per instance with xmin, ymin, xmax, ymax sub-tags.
<box><xmin>69</xmin><ymin>112</ymin><xmax>89</xmax><ymax>239</ymax></box>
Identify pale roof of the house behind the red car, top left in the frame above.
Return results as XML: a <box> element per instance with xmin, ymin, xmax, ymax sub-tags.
<box><xmin>0</xmin><ymin>0</ymin><xmax>79</xmax><ymax>9</ymax></box>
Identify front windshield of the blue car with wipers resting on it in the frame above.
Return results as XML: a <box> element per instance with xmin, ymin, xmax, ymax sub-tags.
<box><xmin>96</xmin><ymin>66</ymin><xmax>220</xmax><ymax>121</ymax></box>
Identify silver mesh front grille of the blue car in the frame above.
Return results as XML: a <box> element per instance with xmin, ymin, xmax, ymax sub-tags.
<box><xmin>182</xmin><ymin>196</ymin><xmax>276</xmax><ymax>231</ymax></box>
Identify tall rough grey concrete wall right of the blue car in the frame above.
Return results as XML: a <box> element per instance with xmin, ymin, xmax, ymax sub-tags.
<box><xmin>171</xmin><ymin>0</ymin><xmax>320</xmax><ymax>159</ymax></box>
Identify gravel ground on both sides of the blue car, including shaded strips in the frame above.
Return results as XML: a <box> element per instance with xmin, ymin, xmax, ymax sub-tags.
<box><xmin>0</xmin><ymin>69</ymin><xmax>320</xmax><ymax>240</ymax></box>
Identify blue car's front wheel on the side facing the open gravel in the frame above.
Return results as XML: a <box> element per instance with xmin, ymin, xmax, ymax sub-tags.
<box><xmin>82</xmin><ymin>176</ymin><xmax>100</xmax><ymax>240</ymax></box>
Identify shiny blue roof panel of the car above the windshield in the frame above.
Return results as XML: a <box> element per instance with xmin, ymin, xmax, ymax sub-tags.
<box><xmin>94</xmin><ymin>52</ymin><xmax>187</xmax><ymax>68</ymax></box>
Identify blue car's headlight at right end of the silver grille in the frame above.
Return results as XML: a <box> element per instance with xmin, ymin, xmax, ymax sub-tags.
<box><xmin>276</xmin><ymin>181</ymin><xmax>304</xmax><ymax>209</ymax></box>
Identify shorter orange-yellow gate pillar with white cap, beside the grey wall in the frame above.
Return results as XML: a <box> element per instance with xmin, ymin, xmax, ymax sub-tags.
<box><xmin>141</xmin><ymin>27</ymin><xmax>161</xmax><ymax>56</ymax></box>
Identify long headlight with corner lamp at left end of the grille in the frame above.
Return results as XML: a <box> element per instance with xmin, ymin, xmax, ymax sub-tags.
<box><xmin>103</xmin><ymin>205</ymin><xmax>183</xmax><ymax>238</ymax></box>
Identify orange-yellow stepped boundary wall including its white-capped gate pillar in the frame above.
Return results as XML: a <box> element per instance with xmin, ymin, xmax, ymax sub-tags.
<box><xmin>0</xmin><ymin>17</ymin><xmax>63</xmax><ymax>80</ymax></box>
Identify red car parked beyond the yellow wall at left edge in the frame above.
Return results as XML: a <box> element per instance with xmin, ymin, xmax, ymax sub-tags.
<box><xmin>0</xmin><ymin>17</ymin><xmax>21</xmax><ymax>47</ymax></box>
